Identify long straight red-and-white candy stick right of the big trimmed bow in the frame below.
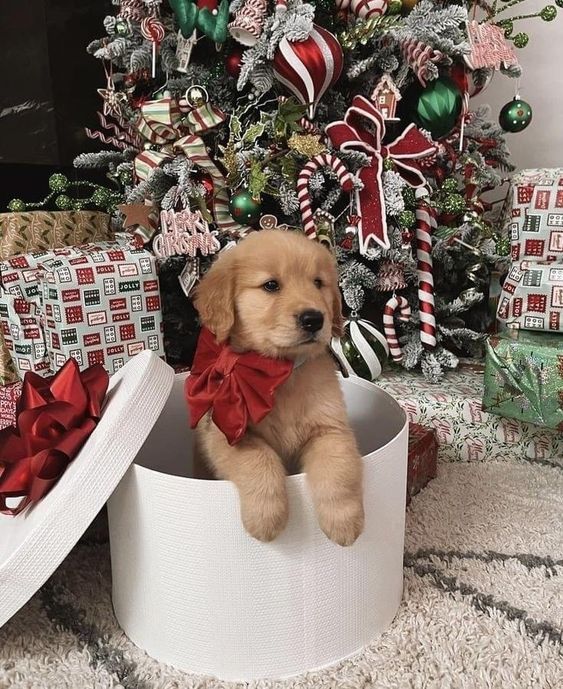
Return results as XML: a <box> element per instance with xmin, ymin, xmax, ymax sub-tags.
<box><xmin>416</xmin><ymin>189</ymin><xmax>437</xmax><ymax>349</ymax></box>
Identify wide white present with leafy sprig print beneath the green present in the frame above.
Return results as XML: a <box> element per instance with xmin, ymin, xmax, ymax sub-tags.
<box><xmin>377</xmin><ymin>370</ymin><xmax>563</xmax><ymax>462</ymax></box>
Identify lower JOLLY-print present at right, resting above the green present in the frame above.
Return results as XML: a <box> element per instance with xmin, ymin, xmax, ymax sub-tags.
<box><xmin>497</xmin><ymin>260</ymin><xmax>563</xmax><ymax>332</ymax></box>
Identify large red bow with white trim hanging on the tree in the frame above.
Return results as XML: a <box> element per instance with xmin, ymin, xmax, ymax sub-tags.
<box><xmin>325</xmin><ymin>96</ymin><xmax>436</xmax><ymax>253</ymax></box>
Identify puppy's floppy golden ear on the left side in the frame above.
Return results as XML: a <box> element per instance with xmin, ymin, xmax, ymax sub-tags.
<box><xmin>194</xmin><ymin>249</ymin><xmax>235</xmax><ymax>342</ymax></box>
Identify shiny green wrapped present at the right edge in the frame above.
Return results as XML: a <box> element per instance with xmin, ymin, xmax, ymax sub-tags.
<box><xmin>483</xmin><ymin>330</ymin><xmax>563</xmax><ymax>431</ymax></box>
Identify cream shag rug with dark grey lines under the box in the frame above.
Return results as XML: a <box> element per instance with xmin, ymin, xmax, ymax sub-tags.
<box><xmin>0</xmin><ymin>460</ymin><xmax>563</xmax><ymax>689</ymax></box>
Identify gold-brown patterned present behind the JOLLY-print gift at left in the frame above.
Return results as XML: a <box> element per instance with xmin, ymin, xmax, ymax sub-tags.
<box><xmin>0</xmin><ymin>211</ymin><xmax>113</xmax><ymax>259</ymax></box>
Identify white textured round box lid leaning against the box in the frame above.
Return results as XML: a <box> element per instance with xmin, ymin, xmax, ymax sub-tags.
<box><xmin>0</xmin><ymin>350</ymin><xmax>174</xmax><ymax>627</ymax></box>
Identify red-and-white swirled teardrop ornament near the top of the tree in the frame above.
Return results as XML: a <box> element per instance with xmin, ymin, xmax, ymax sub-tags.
<box><xmin>274</xmin><ymin>24</ymin><xmax>344</xmax><ymax>119</ymax></box>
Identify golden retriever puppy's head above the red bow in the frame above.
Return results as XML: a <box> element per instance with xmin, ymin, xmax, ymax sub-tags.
<box><xmin>194</xmin><ymin>230</ymin><xmax>342</xmax><ymax>358</ymax></box>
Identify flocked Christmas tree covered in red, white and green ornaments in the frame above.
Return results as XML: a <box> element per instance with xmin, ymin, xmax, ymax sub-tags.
<box><xmin>68</xmin><ymin>0</ymin><xmax>561</xmax><ymax>380</ymax></box>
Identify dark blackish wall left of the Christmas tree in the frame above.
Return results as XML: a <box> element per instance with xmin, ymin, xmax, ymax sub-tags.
<box><xmin>0</xmin><ymin>0</ymin><xmax>112</xmax><ymax>211</ymax></box>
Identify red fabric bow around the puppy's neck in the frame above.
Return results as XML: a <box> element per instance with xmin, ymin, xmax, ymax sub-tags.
<box><xmin>185</xmin><ymin>328</ymin><xmax>293</xmax><ymax>445</ymax></box>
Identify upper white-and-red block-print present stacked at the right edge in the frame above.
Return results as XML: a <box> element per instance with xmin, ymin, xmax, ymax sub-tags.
<box><xmin>502</xmin><ymin>168</ymin><xmax>563</xmax><ymax>263</ymax></box>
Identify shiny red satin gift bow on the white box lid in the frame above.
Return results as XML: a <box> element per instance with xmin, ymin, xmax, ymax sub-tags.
<box><xmin>0</xmin><ymin>358</ymin><xmax>109</xmax><ymax>516</ymax></box>
